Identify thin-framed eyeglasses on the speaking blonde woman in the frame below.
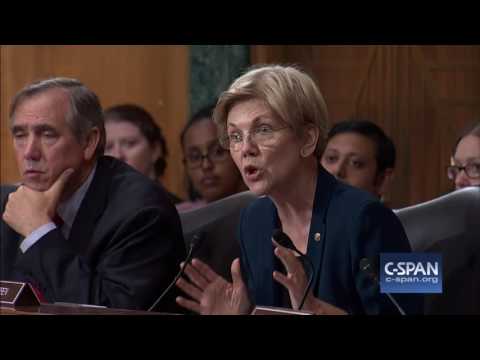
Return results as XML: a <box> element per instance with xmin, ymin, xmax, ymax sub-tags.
<box><xmin>220</xmin><ymin>124</ymin><xmax>290</xmax><ymax>151</ymax></box>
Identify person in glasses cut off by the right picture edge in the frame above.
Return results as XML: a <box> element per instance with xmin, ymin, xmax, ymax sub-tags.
<box><xmin>447</xmin><ymin>122</ymin><xmax>480</xmax><ymax>190</ymax></box>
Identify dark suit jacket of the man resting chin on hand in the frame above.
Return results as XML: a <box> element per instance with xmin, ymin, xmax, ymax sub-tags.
<box><xmin>0</xmin><ymin>156</ymin><xmax>185</xmax><ymax>311</ymax></box>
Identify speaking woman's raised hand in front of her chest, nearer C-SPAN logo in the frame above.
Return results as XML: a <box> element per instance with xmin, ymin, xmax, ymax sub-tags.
<box><xmin>273</xmin><ymin>241</ymin><xmax>347</xmax><ymax>315</ymax></box>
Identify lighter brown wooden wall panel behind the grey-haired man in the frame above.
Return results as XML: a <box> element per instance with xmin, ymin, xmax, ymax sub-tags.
<box><xmin>0</xmin><ymin>46</ymin><xmax>189</xmax><ymax>196</ymax></box>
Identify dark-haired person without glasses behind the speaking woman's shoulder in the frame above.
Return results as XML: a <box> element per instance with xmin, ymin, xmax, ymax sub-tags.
<box><xmin>321</xmin><ymin>120</ymin><xmax>396</xmax><ymax>198</ymax></box>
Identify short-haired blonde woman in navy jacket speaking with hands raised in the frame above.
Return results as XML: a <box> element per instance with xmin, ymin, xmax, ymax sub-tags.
<box><xmin>173</xmin><ymin>65</ymin><xmax>422</xmax><ymax>314</ymax></box>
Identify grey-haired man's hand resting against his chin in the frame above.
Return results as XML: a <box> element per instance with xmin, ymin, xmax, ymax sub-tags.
<box><xmin>3</xmin><ymin>169</ymin><xmax>73</xmax><ymax>237</ymax></box>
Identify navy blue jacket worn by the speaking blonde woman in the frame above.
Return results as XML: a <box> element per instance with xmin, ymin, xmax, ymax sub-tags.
<box><xmin>239</xmin><ymin>166</ymin><xmax>423</xmax><ymax>314</ymax></box>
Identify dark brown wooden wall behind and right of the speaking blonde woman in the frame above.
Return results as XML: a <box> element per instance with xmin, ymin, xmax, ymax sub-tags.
<box><xmin>252</xmin><ymin>45</ymin><xmax>480</xmax><ymax>207</ymax></box>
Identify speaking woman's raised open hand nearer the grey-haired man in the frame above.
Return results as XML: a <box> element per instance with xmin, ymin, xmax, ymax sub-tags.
<box><xmin>176</xmin><ymin>258</ymin><xmax>251</xmax><ymax>315</ymax></box>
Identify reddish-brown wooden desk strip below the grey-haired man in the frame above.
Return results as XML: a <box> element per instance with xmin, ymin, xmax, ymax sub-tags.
<box><xmin>0</xmin><ymin>304</ymin><xmax>169</xmax><ymax>315</ymax></box>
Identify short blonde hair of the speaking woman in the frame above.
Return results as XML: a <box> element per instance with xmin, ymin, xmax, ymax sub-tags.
<box><xmin>213</xmin><ymin>65</ymin><xmax>328</xmax><ymax>156</ymax></box>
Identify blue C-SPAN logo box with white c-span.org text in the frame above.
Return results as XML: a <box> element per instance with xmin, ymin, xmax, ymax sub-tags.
<box><xmin>380</xmin><ymin>253</ymin><xmax>442</xmax><ymax>293</ymax></box>
